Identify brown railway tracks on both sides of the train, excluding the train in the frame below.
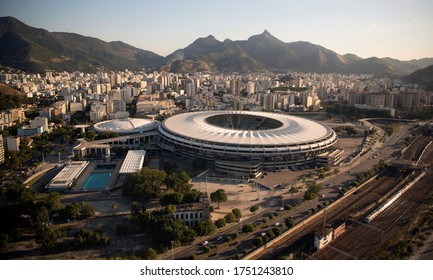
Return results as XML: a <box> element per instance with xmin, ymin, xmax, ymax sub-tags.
<box><xmin>255</xmin><ymin>135</ymin><xmax>433</xmax><ymax>259</ymax></box>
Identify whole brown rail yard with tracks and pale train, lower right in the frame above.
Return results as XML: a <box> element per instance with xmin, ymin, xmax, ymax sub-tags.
<box><xmin>251</xmin><ymin>132</ymin><xmax>433</xmax><ymax>259</ymax></box>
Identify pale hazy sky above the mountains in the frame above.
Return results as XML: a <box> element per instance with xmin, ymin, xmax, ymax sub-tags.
<box><xmin>0</xmin><ymin>0</ymin><xmax>433</xmax><ymax>60</ymax></box>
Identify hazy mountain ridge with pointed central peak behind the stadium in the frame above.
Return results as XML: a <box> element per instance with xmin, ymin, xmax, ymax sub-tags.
<box><xmin>160</xmin><ymin>30</ymin><xmax>433</xmax><ymax>76</ymax></box>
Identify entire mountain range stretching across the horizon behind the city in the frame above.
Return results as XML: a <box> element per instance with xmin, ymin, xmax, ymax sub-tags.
<box><xmin>0</xmin><ymin>17</ymin><xmax>433</xmax><ymax>76</ymax></box>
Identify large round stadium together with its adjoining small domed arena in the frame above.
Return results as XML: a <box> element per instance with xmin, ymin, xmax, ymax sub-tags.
<box><xmin>74</xmin><ymin>111</ymin><xmax>342</xmax><ymax>176</ymax></box>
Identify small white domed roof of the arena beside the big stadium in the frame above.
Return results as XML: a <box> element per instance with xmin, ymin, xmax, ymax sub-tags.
<box><xmin>94</xmin><ymin>118</ymin><xmax>158</xmax><ymax>134</ymax></box>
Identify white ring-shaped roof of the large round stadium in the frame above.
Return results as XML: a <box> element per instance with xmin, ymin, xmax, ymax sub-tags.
<box><xmin>163</xmin><ymin>111</ymin><xmax>333</xmax><ymax>146</ymax></box>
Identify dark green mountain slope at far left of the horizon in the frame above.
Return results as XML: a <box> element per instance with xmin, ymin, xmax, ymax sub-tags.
<box><xmin>0</xmin><ymin>17</ymin><xmax>165</xmax><ymax>72</ymax></box>
